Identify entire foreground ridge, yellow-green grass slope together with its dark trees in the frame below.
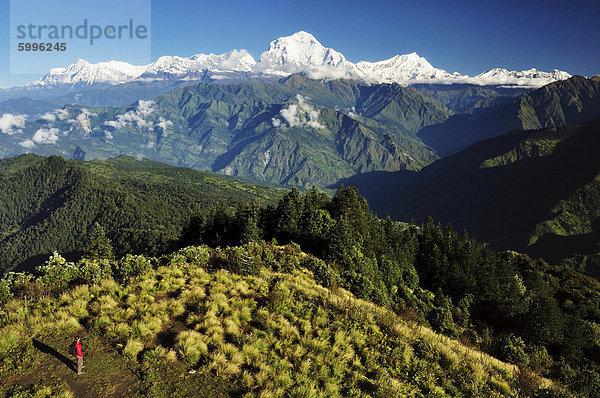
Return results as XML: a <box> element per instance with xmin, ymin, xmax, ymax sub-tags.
<box><xmin>0</xmin><ymin>187</ymin><xmax>600</xmax><ymax>397</ymax></box>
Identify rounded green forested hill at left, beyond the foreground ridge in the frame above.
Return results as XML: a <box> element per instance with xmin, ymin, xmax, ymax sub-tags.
<box><xmin>0</xmin><ymin>155</ymin><xmax>280</xmax><ymax>272</ymax></box>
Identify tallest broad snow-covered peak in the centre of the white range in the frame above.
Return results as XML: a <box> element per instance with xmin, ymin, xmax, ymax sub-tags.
<box><xmin>257</xmin><ymin>31</ymin><xmax>350</xmax><ymax>75</ymax></box>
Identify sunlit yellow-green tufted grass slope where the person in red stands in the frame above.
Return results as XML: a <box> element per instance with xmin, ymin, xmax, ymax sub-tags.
<box><xmin>0</xmin><ymin>245</ymin><xmax>556</xmax><ymax>397</ymax></box>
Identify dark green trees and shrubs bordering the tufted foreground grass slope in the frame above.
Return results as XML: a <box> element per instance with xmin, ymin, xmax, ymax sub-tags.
<box><xmin>2</xmin><ymin>187</ymin><xmax>600</xmax><ymax>396</ymax></box>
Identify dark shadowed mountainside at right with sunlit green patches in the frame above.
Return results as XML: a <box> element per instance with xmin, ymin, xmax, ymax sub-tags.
<box><xmin>344</xmin><ymin>115</ymin><xmax>600</xmax><ymax>276</ymax></box>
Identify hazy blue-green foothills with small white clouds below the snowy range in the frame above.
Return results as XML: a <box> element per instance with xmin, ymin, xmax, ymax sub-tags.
<box><xmin>0</xmin><ymin>75</ymin><xmax>451</xmax><ymax>187</ymax></box>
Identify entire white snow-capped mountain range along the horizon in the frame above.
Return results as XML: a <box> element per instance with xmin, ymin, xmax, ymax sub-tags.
<box><xmin>28</xmin><ymin>31</ymin><xmax>571</xmax><ymax>87</ymax></box>
